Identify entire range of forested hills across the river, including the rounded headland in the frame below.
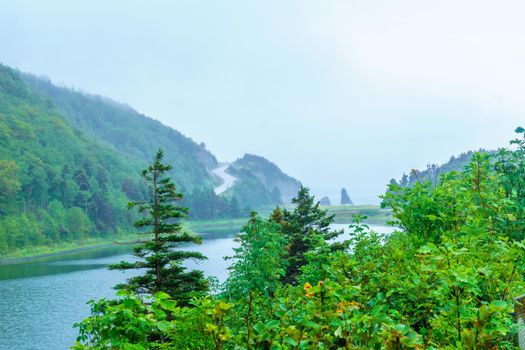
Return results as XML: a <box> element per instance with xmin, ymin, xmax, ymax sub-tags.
<box><xmin>0</xmin><ymin>65</ymin><xmax>298</xmax><ymax>257</ymax></box>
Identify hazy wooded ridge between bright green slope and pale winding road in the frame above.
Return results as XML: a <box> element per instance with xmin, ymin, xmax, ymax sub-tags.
<box><xmin>23</xmin><ymin>74</ymin><xmax>244</xmax><ymax>220</ymax></box>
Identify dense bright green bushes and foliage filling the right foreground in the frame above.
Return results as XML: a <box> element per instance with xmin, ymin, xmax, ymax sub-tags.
<box><xmin>76</xmin><ymin>129</ymin><xmax>525</xmax><ymax>349</ymax></box>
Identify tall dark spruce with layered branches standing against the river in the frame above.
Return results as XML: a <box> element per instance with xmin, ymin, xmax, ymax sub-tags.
<box><xmin>110</xmin><ymin>149</ymin><xmax>207</xmax><ymax>305</ymax></box>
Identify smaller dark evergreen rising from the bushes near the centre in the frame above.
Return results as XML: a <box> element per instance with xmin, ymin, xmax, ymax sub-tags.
<box><xmin>278</xmin><ymin>186</ymin><xmax>342</xmax><ymax>284</ymax></box>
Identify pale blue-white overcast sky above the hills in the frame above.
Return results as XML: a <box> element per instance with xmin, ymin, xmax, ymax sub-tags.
<box><xmin>0</xmin><ymin>0</ymin><xmax>525</xmax><ymax>203</ymax></box>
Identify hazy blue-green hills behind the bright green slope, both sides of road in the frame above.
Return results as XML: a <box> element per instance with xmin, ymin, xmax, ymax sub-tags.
<box><xmin>23</xmin><ymin>74</ymin><xmax>298</xmax><ymax>220</ymax></box>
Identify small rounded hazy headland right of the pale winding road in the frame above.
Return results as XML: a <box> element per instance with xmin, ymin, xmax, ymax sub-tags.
<box><xmin>226</xmin><ymin>154</ymin><xmax>301</xmax><ymax>207</ymax></box>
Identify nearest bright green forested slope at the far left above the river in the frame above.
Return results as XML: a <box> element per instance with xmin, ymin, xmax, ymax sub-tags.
<box><xmin>0</xmin><ymin>66</ymin><xmax>138</xmax><ymax>255</ymax></box>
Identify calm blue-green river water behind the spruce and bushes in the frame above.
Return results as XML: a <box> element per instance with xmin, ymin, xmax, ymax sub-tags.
<box><xmin>0</xmin><ymin>224</ymin><xmax>392</xmax><ymax>350</ymax></box>
